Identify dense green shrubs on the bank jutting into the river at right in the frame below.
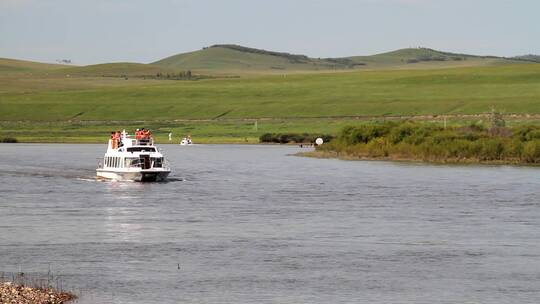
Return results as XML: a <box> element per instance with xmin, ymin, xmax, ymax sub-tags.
<box><xmin>308</xmin><ymin>120</ymin><xmax>540</xmax><ymax>164</ymax></box>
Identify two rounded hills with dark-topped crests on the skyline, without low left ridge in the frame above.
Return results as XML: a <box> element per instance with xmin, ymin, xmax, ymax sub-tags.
<box><xmin>153</xmin><ymin>44</ymin><xmax>534</xmax><ymax>72</ymax></box>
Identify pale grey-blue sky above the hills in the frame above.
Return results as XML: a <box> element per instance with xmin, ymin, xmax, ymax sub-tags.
<box><xmin>0</xmin><ymin>0</ymin><xmax>540</xmax><ymax>64</ymax></box>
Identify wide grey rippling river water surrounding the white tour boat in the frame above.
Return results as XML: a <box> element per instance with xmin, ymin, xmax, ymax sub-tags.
<box><xmin>0</xmin><ymin>144</ymin><xmax>540</xmax><ymax>303</ymax></box>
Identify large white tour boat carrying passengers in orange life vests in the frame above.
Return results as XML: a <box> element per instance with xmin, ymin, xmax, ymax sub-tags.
<box><xmin>96</xmin><ymin>130</ymin><xmax>171</xmax><ymax>182</ymax></box>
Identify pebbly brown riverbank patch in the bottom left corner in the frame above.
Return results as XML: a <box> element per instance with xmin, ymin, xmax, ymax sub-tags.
<box><xmin>0</xmin><ymin>282</ymin><xmax>76</xmax><ymax>304</ymax></box>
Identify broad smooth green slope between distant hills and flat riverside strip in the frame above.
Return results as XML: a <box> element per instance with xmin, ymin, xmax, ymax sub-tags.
<box><xmin>0</xmin><ymin>64</ymin><xmax>540</xmax><ymax>121</ymax></box>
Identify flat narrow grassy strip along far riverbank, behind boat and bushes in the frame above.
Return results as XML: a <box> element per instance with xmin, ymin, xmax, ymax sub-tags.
<box><xmin>0</xmin><ymin>114</ymin><xmax>540</xmax><ymax>144</ymax></box>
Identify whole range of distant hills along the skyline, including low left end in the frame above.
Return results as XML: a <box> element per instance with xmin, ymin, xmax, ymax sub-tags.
<box><xmin>0</xmin><ymin>44</ymin><xmax>540</xmax><ymax>77</ymax></box>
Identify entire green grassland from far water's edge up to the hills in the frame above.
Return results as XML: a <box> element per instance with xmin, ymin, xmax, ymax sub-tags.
<box><xmin>0</xmin><ymin>54</ymin><xmax>540</xmax><ymax>142</ymax></box>
